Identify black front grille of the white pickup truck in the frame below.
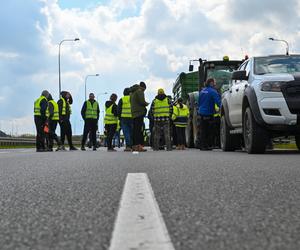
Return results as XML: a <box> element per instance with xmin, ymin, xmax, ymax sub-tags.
<box><xmin>281</xmin><ymin>81</ymin><xmax>300</xmax><ymax>114</ymax></box>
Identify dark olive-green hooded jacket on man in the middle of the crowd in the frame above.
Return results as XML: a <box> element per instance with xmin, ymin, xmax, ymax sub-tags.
<box><xmin>130</xmin><ymin>84</ymin><xmax>149</xmax><ymax>118</ymax></box>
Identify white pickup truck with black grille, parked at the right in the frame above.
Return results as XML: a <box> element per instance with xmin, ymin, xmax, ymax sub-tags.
<box><xmin>221</xmin><ymin>55</ymin><xmax>300</xmax><ymax>153</ymax></box>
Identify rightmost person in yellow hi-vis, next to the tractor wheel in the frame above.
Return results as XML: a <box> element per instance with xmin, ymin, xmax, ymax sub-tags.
<box><xmin>172</xmin><ymin>98</ymin><xmax>190</xmax><ymax>150</ymax></box>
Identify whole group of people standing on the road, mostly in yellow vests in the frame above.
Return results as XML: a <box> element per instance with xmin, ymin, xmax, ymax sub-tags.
<box><xmin>34</xmin><ymin>79</ymin><xmax>221</xmax><ymax>152</ymax></box>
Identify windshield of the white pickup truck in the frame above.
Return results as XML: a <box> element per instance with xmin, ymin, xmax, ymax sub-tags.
<box><xmin>254</xmin><ymin>56</ymin><xmax>300</xmax><ymax>75</ymax></box>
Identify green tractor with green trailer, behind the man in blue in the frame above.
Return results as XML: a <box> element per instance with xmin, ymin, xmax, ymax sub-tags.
<box><xmin>173</xmin><ymin>56</ymin><xmax>242</xmax><ymax>148</ymax></box>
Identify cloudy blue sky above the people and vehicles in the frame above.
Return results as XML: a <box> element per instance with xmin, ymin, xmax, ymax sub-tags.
<box><xmin>0</xmin><ymin>0</ymin><xmax>300</xmax><ymax>134</ymax></box>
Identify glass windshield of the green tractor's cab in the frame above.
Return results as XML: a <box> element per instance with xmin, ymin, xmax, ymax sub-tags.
<box><xmin>207</xmin><ymin>65</ymin><xmax>235</xmax><ymax>92</ymax></box>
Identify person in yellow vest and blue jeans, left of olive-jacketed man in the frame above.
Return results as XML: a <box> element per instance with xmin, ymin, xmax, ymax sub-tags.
<box><xmin>118</xmin><ymin>88</ymin><xmax>133</xmax><ymax>152</ymax></box>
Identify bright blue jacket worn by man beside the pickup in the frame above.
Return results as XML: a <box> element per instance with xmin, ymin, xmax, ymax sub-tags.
<box><xmin>198</xmin><ymin>87</ymin><xmax>221</xmax><ymax>116</ymax></box>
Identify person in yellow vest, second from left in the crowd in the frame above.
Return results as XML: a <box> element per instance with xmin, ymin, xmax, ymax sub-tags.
<box><xmin>46</xmin><ymin>95</ymin><xmax>61</xmax><ymax>151</ymax></box>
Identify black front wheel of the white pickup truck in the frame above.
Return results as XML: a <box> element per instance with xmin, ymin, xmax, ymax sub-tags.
<box><xmin>243</xmin><ymin>107</ymin><xmax>268</xmax><ymax>154</ymax></box>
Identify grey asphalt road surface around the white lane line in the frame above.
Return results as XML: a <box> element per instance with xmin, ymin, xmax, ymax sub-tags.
<box><xmin>0</xmin><ymin>149</ymin><xmax>300</xmax><ymax>250</ymax></box>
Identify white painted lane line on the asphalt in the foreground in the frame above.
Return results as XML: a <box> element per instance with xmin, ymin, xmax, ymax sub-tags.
<box><xmin>109</xmin><ymin>173</ymin><xmax>174</xmax><ymax>250</ymax></box>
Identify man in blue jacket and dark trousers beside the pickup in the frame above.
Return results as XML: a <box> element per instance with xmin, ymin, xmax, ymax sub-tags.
<box><xmin>198</xmin><ymin>78</ymin><xmax>221</xmax><ymax>150</ymax></box>
